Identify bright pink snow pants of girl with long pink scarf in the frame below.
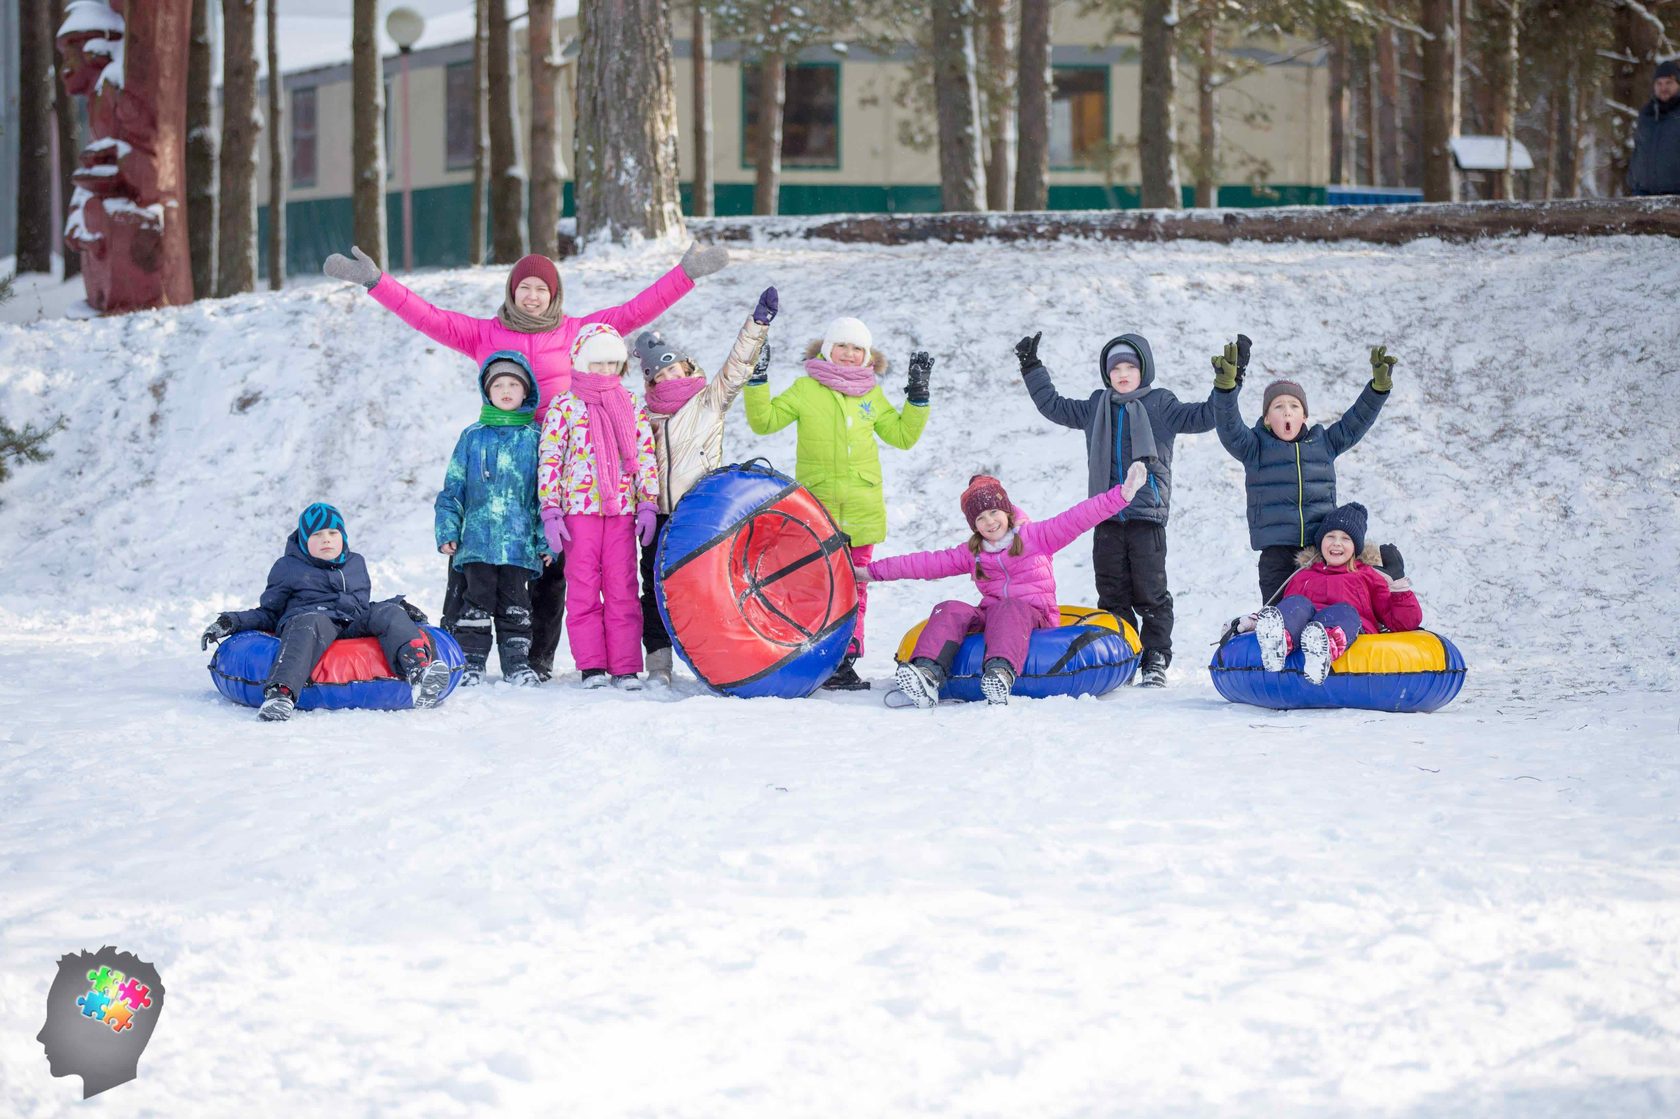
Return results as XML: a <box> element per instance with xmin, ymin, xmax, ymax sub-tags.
<box><xmin>566</xmin><ymin>512</ymin><xmax>642</xmax><ymax>675</ymax></box>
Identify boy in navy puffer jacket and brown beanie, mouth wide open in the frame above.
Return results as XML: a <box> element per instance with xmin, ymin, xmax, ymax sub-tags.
<box><xmin>1213</xmin><ymin>334</ymin><xmax>1396</xmax><ymax>603</ymax></box>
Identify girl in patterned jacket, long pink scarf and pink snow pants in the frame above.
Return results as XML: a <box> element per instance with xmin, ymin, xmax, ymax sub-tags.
<box><xmin>536</xmin><ymin>323</ymin><xmax>659</xmax><ymax>691</ymax></box>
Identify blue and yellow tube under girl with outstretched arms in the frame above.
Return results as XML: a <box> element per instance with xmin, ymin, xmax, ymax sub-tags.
<box><xmin>894</xmin><ymin>607</ymin><xmax>1142</xmax><ymax>702</ymax></box>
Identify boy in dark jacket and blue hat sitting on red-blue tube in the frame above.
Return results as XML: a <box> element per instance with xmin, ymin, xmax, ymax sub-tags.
<box><xmin>200</xmin><ymin>501</ymin><xmax>449</xmax><ymax>722</ymax></box>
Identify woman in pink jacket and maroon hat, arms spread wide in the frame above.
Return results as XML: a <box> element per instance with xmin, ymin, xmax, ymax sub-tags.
<box><xmin>321</xmin><ymin>245</ymin><xmax>729</xmax><ymax>680</ymax></box>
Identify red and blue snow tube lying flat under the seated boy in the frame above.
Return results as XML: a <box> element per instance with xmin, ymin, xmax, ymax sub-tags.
<box><xmin>210</xmin><ymin>625</ymin><xmax>467</xmax><ymax>711</ymax></box>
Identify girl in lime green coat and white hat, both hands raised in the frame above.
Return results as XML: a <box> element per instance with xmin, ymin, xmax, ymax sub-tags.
<box><xmin>743</xmin><ymin>318</ymin><xmax>934</xmax><ymax>691</ymax></box>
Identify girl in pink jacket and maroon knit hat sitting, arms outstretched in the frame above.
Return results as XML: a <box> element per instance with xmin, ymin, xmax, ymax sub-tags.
<box><xmin>857</xmin><ymin>462</ymin><xmax>1149</xmax><ymax>707</ymax></box>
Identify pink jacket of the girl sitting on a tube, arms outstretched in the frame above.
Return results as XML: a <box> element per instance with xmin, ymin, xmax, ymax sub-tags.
<box><xmin>869</xmin><ymin>486</ymin><xmax>1126</xmax><ymax>613</ymax></box>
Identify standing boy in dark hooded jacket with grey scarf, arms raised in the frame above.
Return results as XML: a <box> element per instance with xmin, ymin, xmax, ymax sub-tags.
<box><xmin>1015</xmin><ymin>333</ymin><xmax>1213</xmax><ymax>687</ymax></box>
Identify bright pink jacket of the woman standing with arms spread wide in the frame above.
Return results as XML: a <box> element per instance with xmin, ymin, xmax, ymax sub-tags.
<box><xmin>368</xmin><ymin>265</ymin><xmax>694</xmax><ymax>423</ymax></box>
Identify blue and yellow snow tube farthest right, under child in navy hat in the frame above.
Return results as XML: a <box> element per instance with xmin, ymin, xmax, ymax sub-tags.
<box><xmin>1208</xmin><ymin>630</ymin><xmax>1465</xmax><ymax>712</ymax></box>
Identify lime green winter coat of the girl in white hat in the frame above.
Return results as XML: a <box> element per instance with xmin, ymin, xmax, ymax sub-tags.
<box><xmin>743</xmin><ymin>344</ymin><xmax>927</xmax><ymax>546</ymax></box>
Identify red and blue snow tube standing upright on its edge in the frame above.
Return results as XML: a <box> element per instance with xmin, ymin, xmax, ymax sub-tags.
<box><xmin>654</xmin><ymin>460</ymin><xmax>857</xmax><ymax>699</ymax></box>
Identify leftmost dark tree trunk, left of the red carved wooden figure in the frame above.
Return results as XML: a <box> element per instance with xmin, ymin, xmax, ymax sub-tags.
<box><xmin>17</xmin><ymin>0</ymin><xmax>59</xmax><ymax>272</ymax></box>
